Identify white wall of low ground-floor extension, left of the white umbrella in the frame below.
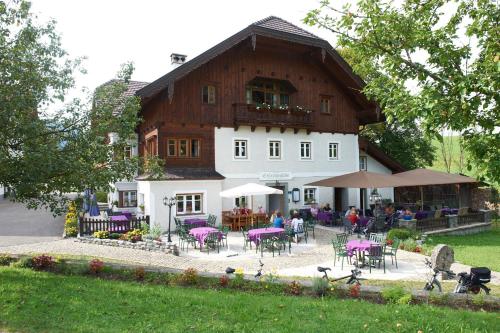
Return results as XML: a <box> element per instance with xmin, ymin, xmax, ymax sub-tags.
<box><xmin>137</xmin><ymin>180</ymin><xmax>222</xmax><ymax>230</ymax></box>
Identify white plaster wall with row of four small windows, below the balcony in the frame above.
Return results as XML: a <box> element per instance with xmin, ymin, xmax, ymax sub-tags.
<box><xmin>215</xmin><ymin>126</ymin><xmax>359</xmax><ymax>210</ymax></box>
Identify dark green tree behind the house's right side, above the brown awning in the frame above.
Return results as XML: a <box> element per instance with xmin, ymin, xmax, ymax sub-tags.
<box><xmin>360</xmin><ymin>121</ymin><xmax>434</xmax><ymax>170</ymax></box>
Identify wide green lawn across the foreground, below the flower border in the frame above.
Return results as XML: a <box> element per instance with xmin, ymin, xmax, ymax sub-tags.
<box><xmin>0</xmin><ymin>267</ymin><xmax>500</xmax><ymax>333</ymax></box>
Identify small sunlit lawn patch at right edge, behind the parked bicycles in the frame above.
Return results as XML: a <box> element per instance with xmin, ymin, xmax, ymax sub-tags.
<box><xmin>425</xmin><ymin>223</ymin><xmax>500</xmax><ymax>272</ymax></box>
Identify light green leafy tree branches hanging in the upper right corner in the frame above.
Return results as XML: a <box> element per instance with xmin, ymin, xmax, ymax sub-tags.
<box><xmin>305</xmin><ymin>0</ymin><xmax>500</xmax><ymax>184</ymax></box>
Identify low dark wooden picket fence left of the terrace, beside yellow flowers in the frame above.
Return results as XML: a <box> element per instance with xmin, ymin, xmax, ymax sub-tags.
<box><xmin>78</xmin><ymin>215</ymin><xmax>149</xmax><ymax>236</ymax></box>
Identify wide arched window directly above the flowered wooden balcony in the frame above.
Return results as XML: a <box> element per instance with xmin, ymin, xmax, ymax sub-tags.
<box><xmin>246</xmin><ymin>79</ymin><xmax>292</xmax><ymax>107</ymax></box>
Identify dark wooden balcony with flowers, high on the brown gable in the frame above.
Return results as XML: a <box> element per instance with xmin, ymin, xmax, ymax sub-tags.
<box><xmin>233</xmin><ymin>103</ymin><xmax>313</xmax><ymax>131</ymax></box>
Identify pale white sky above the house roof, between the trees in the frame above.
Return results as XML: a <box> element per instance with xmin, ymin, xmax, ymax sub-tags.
<box><xmin>32</xmin><ymin>0</ymin><xmax>334</xmax><ymax>94</ymax></box>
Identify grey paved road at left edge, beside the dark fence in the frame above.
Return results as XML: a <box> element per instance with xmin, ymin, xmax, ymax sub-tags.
<box><xmin>0</xmin><ymin>199</ymin><xmax>64</xmax><ymax>249</ymax></box>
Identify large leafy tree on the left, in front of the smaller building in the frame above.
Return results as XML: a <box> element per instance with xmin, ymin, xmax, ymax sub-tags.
<box><xmin>0</xmin><ymin>0</ymin><xmax>151</xmax><ymax>214</ymax></box>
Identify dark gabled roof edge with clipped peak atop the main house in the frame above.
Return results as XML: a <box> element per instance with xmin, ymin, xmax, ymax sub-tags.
<box><xmin>137</xmin><ymin>16</ymin><xmax>365</xmax><ymax>105</ymax></box>
